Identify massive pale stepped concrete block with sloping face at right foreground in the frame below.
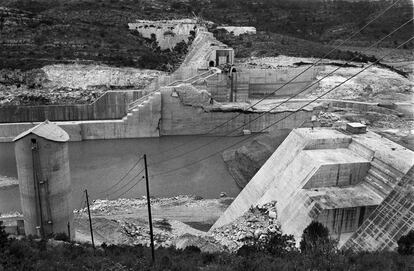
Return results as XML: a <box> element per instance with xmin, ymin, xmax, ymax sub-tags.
<box><xmin>213</xmin><ymin>128</ymin><xmax>414</xmax><ymax>249</ymax></box>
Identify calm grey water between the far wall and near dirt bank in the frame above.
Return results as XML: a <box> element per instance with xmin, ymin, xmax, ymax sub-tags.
<box><xmin>0</xmin><ymin>136</ymin><xmax>253</xmax><ymax>213</ymax></box>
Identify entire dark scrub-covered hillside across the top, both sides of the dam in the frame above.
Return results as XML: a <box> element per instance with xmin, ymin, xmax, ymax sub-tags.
<box><xmin>0</xmin><ymin>0</ymin><xmax>414</xmax><ymax>71</ymax></box>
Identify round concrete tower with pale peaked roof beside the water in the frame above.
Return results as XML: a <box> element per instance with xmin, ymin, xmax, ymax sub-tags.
<box><xmin>13</xmin><ymin>121</ymin><xmax>74</xmax><ymax>239</ymax></box>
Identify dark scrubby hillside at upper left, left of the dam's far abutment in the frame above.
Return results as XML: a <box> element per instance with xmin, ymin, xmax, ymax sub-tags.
<box><xmin>0</xmin><ymin>0</ymin><xmax>192</xmax><ymax>70</ymax></box>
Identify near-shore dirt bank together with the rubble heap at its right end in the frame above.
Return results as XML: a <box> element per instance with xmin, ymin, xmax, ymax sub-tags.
<box><xmin>74</xmin><ymin>196</ymin><xmax>280</xmax><ymax>252</ymax></box>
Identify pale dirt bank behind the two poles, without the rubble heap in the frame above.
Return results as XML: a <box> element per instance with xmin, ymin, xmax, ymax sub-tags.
<box><xmin>75</xmin><ymin>196</ymin><xmax>233</xmax><ymax>250</ymax></box>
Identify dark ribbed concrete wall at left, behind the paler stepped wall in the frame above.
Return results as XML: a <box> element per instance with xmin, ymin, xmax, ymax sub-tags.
<box><xmin>0</xmin><ymin>90</ymin><xmax>143</xmax><ymax>123</ymax></box>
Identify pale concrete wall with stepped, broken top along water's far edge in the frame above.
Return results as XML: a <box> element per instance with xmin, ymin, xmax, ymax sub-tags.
<box><xmin>0</xmin><ymin>84</ymin><xmax>313</xmax><ymax>142</ymax></box>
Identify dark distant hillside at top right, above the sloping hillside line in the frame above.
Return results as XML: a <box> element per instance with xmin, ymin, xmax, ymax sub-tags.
<box><xmin>200</xmin><ymin>0</ymin><xmax>414</xmax><ymax>48</ymax></box>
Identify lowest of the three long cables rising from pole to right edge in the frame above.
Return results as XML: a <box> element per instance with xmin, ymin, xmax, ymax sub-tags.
<box><xmin>151</xmin><ymin>37</ymin><xmax>414</xmax><ymax>181</ymax></box>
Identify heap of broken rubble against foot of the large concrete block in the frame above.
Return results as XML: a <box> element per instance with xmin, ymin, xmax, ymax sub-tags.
<box><xmin>211</xmin><ymin>201</ymin><xmax>280</xmax><ymax>252</ymax></box>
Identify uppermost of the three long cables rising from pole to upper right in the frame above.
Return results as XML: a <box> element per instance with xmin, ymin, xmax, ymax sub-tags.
<box><xmin>143</xmin><ymin>0</ymin><xmax>401</xmax><ymax>160</ymax></box>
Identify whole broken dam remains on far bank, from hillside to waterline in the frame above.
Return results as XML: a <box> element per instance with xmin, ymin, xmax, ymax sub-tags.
<box><xmin>0</xmin><ymin>20</ymin><xmax>399</xmax><ymax>142</ymax></box>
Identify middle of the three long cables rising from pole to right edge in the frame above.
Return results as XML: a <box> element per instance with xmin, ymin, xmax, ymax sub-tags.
<box><xmin>147</xmin><ymin>19</ymin><xmax>413</xmax><ymax>168</ymax></box>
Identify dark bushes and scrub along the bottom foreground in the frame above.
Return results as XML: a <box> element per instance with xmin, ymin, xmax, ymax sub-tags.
<box><xmin>0</xmin><ymin>221</ymin><xmax>414</xmax><ymax>271</ymax></box>
